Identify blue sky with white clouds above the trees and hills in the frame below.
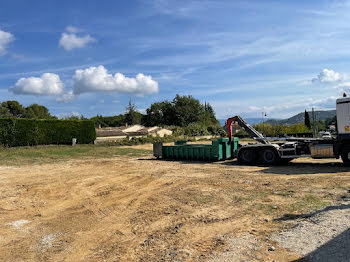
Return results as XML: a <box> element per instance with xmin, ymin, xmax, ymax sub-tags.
<box><xmin>0</xmin><ymin>0</ymin><xmax>350</xmax><ymax>119</ymax></box>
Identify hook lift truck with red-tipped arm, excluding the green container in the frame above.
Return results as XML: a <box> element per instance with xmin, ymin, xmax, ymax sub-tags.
<box><xmin>227</xmin><ymin>93</ymin><xmax>350</xmax><ymax>166</ymax></box>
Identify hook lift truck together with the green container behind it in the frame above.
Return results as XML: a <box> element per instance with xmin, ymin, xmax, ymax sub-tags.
<box><xmin>153</xmin><ymin>93</ymin><xmax>350</xmax><ymax>166</ymax></box>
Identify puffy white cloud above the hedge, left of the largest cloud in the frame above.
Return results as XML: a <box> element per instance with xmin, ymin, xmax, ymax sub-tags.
<box><xmin>10</xmin><ymin>73</ymin><xmax>64</xmax><ymax>95</ymax></box>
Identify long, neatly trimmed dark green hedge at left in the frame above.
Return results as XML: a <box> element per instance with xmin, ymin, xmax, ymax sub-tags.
<box><xmin>0</xmin><ymin>118</ymin><xmax>96</xmax><ymax>147</ymax></box>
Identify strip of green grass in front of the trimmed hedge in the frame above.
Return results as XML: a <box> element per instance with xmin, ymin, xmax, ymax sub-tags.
<box><xmin>0</xmin><ymin>145</ymin><xmax>152</xmax><ymax>165</ymax></box>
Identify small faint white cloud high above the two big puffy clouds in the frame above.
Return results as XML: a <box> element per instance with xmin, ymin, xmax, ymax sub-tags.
<box><xmin>59</xmin><ymin>26</ymin><xmax>96</xmax><ymax>51</ymax></box>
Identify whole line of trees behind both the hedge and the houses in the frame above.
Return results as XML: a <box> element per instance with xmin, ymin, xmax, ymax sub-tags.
<box><xmin>0</xmin><ymin>95</ymin><xmax>225</xmax><ymax>136</ymax></box>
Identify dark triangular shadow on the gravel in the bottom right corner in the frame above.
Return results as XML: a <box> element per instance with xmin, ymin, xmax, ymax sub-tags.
<box><xmin>294</xmin><ymin>229</ymin><xmax>350</xmax><ymax>262</ymax></box>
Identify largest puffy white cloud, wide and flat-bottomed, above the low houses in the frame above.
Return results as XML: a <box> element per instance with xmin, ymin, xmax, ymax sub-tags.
<box><xmin>73</xmin><ymin>65</ymin><xmax>158</xmax><ymax>95</ymax></box>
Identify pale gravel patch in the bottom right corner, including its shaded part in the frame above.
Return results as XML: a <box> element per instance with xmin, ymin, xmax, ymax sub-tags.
<box><xmin>272</xmin><ymin>202</ymin><xmax>350</xmax><ymax>262</ymax></box>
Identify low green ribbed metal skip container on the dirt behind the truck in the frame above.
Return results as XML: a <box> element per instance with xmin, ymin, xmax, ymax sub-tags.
<box><xmin>153</xmin><ymin>137</ymin><xmax>239</xmax><ymax>161</ymax></box>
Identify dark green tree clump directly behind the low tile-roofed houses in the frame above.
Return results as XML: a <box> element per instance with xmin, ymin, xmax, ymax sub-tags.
<box><xmin>91</xmin><ymin>95</ymin><xmax>225</xmax><ymax>135</ymax></box>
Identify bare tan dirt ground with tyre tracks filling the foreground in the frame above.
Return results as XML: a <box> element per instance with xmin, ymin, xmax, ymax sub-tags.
<box><xmin>0</xmin><ymin>145</ymin><xmax>350</xmax><ymax>261</ymax></box>
